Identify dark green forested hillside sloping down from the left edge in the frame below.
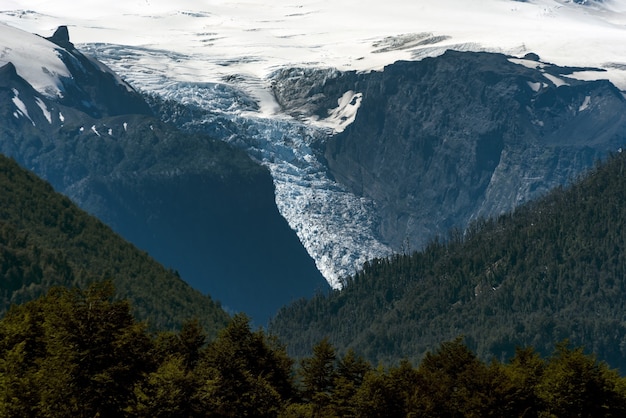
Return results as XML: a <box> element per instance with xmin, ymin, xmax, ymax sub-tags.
<box><xmin>0</xmin><ymin>156</ymin><xmax>228</xmax><ymax>336</ymax></box>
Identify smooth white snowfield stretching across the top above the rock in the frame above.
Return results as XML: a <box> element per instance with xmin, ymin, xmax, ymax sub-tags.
<box><xmin>0</xmin><ymin>0</ymin><xmax>626</xmax><ymax>94</ymax></box>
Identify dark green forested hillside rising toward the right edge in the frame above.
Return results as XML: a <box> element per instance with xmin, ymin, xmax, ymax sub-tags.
<box><xmin>270</xmin><ymin>149</ymin><xmax>626</xmax><ymax>371</ymax></box>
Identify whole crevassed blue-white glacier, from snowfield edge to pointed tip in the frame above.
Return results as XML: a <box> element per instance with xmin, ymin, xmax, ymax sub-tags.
<box><xmin>82</xmin><ymin>44</ymin><xmax>392</xmax><ymax>289</ymax></box>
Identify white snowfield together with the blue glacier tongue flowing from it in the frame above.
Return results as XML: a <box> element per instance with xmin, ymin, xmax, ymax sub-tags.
<box><xmin>0</xmin><ymin>0</ymin><xmax>626</xmax><ymax>287</ymax></box>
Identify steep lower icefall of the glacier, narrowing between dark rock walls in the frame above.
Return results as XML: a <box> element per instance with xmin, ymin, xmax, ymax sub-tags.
<box><xmin>223</xmin><ymin>116</ymin><xmax>392</xmax><ymax>289</ymax></box>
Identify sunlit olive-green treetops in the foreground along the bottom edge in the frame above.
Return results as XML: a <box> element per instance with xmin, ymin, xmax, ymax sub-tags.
<box><xmin>0</xmin><ymin>281</ymin><xmax>626</xmax><ymax>418</ymax></box>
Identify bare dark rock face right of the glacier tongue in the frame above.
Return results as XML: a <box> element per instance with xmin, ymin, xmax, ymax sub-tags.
<box><xmin>279</xmin><ymin>51</ymin><xmax>626</xmax><ymax>249</ymax></box>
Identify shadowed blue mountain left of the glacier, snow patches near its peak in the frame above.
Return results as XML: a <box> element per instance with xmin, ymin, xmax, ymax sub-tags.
<box><xmin>0</xmin><ymin>22</ymin><xmax>327</xmax><ymax>324</ymax></box>
